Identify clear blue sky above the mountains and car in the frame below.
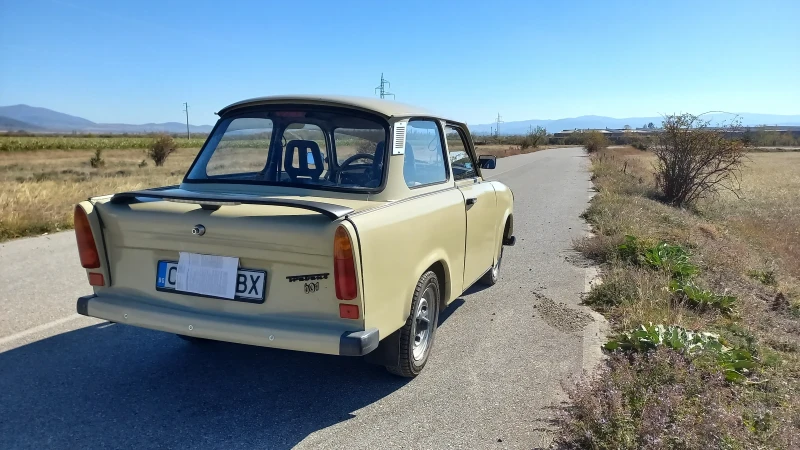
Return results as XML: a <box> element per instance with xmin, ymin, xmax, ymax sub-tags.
<box><xmin>0</xmin><ymin>0</ymin><xmax>800</xmax><ymax>124</ymax></box>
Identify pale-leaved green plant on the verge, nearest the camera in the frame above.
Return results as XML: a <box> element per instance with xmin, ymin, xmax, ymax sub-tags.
<box><xmin>603</xmin><ymin>323</ymin><xmax>756</xmax><ymax>382</ymax></box>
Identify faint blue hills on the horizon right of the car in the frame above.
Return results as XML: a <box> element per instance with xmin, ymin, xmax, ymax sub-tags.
<box><xmin>469</xmin><ymin>113</ymin><xmax>800</xmax><ymax>134</ymax></box>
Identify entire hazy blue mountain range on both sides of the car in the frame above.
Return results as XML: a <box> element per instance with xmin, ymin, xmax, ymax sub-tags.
<box><xmin>0</xmin><ymin>105</ymin><xmax>800</xmax><ymax>134</ymax></box>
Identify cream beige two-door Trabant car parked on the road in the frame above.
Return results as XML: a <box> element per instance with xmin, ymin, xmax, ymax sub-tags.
<box><xmin>75</xmin><ymin>96</ymin><xmax>514</xmax><ymax>377</ymax></box>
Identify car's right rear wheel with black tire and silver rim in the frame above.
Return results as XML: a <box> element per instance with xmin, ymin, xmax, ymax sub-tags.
<box><xmin>386</xmin><ymin>271</ymin><xmax>441</xmax><ymax>378</ymax></box>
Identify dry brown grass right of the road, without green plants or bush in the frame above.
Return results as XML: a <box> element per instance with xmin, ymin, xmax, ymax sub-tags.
<box><xmin>560</xmin><ymin>148</ymin><xmax>800</xmax><ymax>448</ymax></box>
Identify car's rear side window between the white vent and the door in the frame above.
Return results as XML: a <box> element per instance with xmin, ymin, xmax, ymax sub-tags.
<box><xmin>403</xmin><ymin>120</ymin><xmax>447</xmax><ymax>187</ymax></box>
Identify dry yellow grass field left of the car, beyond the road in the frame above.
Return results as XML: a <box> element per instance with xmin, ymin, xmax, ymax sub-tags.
<box><xmin>0</xmin><ymin>149</ymin><xmax>197</xmax><ymax>241</ymax></box>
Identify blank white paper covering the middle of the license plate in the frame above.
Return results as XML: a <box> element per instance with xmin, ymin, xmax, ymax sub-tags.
<box><xmin>175</xmin><ymin>252</ymin><xmax>239</xmax><ymax>298</ymax></box>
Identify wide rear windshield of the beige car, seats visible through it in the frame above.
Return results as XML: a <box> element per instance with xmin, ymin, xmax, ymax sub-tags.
<box><xmin>186</xmin><ymin>109</ymin><xmax>388</xmax><ymax>190</ymax></box>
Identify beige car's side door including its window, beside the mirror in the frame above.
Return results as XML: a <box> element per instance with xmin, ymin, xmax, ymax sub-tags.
<box><xmin>445</xmin><ymin>124</ymin><xmax>499</xmax><ymax>286</ymax></box>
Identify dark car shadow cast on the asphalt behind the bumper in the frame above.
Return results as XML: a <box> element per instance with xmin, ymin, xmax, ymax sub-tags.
<box><xmin>0</xmin><ymin>324</ymin><xmax>412</xmax><ymax>449</ymax></box>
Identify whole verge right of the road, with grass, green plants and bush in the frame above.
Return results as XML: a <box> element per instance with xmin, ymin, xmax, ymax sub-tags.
<box><xmin>554</xmin><ymin>117</ymin><xmax>800</xmax><ymax>449</ymax></box>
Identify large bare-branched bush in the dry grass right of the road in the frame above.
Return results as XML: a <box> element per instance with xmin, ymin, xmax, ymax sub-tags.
<box><xmin>653</xmin><ymin>114</ymin><xmax>745</xmax><ymax>207</ymax></box>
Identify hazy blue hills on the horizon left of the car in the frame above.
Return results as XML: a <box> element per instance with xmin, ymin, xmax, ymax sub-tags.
<box><xmin>0</xmin><ymin>105</ymin><xmax>212</xmax><ymax>133</ymax></box>
